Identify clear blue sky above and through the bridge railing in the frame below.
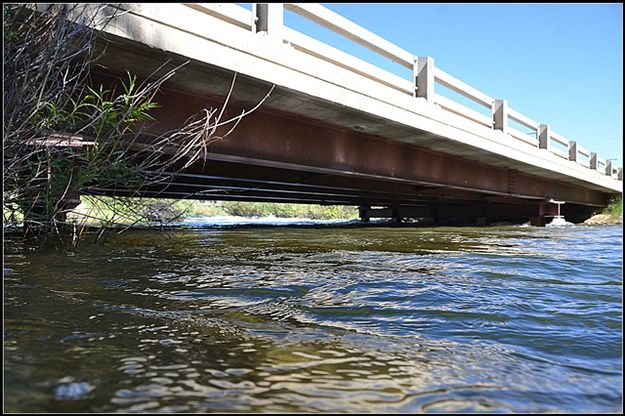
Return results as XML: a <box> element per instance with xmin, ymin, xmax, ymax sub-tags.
<box><xmin>274</xmin><ymin>3</ymin><xmax>623</xmax><ymax>166</ymax></box>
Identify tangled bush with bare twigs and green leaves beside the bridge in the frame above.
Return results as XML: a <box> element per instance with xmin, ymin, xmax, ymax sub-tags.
<box><xmin>3</xmin><ymin>4</ymin><xmax>167</xmax><ymax>237</ymax></box>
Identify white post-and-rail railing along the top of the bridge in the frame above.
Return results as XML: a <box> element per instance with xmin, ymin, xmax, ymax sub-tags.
<box><xmin>187</xmin><ymin>3</ymin><xmax>623</xmax><ymax>180</ymax></box>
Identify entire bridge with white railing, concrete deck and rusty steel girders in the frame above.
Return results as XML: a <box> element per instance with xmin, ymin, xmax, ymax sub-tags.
<box><xmin>72</xmin><ymin>3</ymin><xmax>622</xmax><ymax>225</ymax></box>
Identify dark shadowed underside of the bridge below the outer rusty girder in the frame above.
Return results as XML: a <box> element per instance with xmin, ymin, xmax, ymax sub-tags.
<box><xmin>81</xmin><ymin>154</ymin><xmax>596</xmax><ymax>225</ymax></box>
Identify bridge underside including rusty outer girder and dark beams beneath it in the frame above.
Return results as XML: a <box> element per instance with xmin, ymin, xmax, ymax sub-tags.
<box><xmin>80</xmin><ymin>72</ymin><xmax>609</xmax><ymax>224</ymax></box>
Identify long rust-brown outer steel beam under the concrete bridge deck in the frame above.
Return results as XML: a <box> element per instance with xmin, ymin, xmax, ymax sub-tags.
<box><xmin>125</xmin><ymin>85</ymin><xmax>606</xmax><ymax>205</ymax></box>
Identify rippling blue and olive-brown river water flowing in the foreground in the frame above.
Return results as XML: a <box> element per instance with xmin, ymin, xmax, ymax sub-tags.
<box><xmin>4</xmin><ymin>226</ymin><xmax>623</xmax><ymax>413</ymax></box>
